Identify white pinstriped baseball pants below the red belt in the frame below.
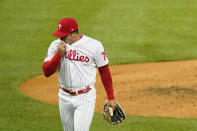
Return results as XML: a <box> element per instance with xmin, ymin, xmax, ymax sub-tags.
<box><xmin>58</xmin><ymin>87</ymin><xmax>96</xmax><ymax>131</ymax></box>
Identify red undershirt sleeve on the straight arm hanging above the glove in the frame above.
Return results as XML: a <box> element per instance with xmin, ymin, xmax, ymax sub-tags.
<box><xmin>98</xmin><ymin>65</ymin><xmax>115</xmax><ymax>100</ymax></box>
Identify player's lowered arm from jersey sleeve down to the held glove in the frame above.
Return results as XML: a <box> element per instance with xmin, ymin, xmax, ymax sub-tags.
<box><xmin>95</xmin><ymin>44</ymin><xmax>125</xmax><ymax>125</ymax></box>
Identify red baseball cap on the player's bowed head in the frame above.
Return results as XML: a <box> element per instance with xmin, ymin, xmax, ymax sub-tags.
<box><xmin>53</xmin><ymin>18</ymin><xmax>78</xmax><ymax>37</ymax></box>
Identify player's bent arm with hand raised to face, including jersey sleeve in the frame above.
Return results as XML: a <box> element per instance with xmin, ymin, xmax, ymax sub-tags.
<box><xmin>42</xmin><ymin>41</ymin><xmax>66</xmax><ymax>77</ymax></box>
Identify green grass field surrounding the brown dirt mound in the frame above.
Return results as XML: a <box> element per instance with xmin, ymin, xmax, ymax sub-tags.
<box><xmin>0</xmin><ymin>0</ymin><xmax>197</xmax><ymax>131</ymax></box>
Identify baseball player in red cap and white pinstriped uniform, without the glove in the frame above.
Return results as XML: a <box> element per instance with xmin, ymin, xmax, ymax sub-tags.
<box><xmin>43</xmin><ymin>18</ymin><xmax>120</xmax><ymax>131</ymax></box>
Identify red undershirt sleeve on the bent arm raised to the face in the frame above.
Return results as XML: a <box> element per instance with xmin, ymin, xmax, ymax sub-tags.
<box><xmin>42</xmin><ymin>52</ymin><xmax>62</xmax><ymax>77</ymax></box>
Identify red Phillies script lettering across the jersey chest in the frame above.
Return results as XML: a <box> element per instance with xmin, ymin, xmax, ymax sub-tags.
<box><xmin>65</xmin><ymin>50</ymin><xmax>89</xmax><ymax>62</ymax></box>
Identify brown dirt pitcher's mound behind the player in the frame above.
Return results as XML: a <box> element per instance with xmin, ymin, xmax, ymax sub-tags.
<box><xmin>19</xmin><ymin>61</ymin><xmax>197</xmax><ymax>118</ymax></box>
